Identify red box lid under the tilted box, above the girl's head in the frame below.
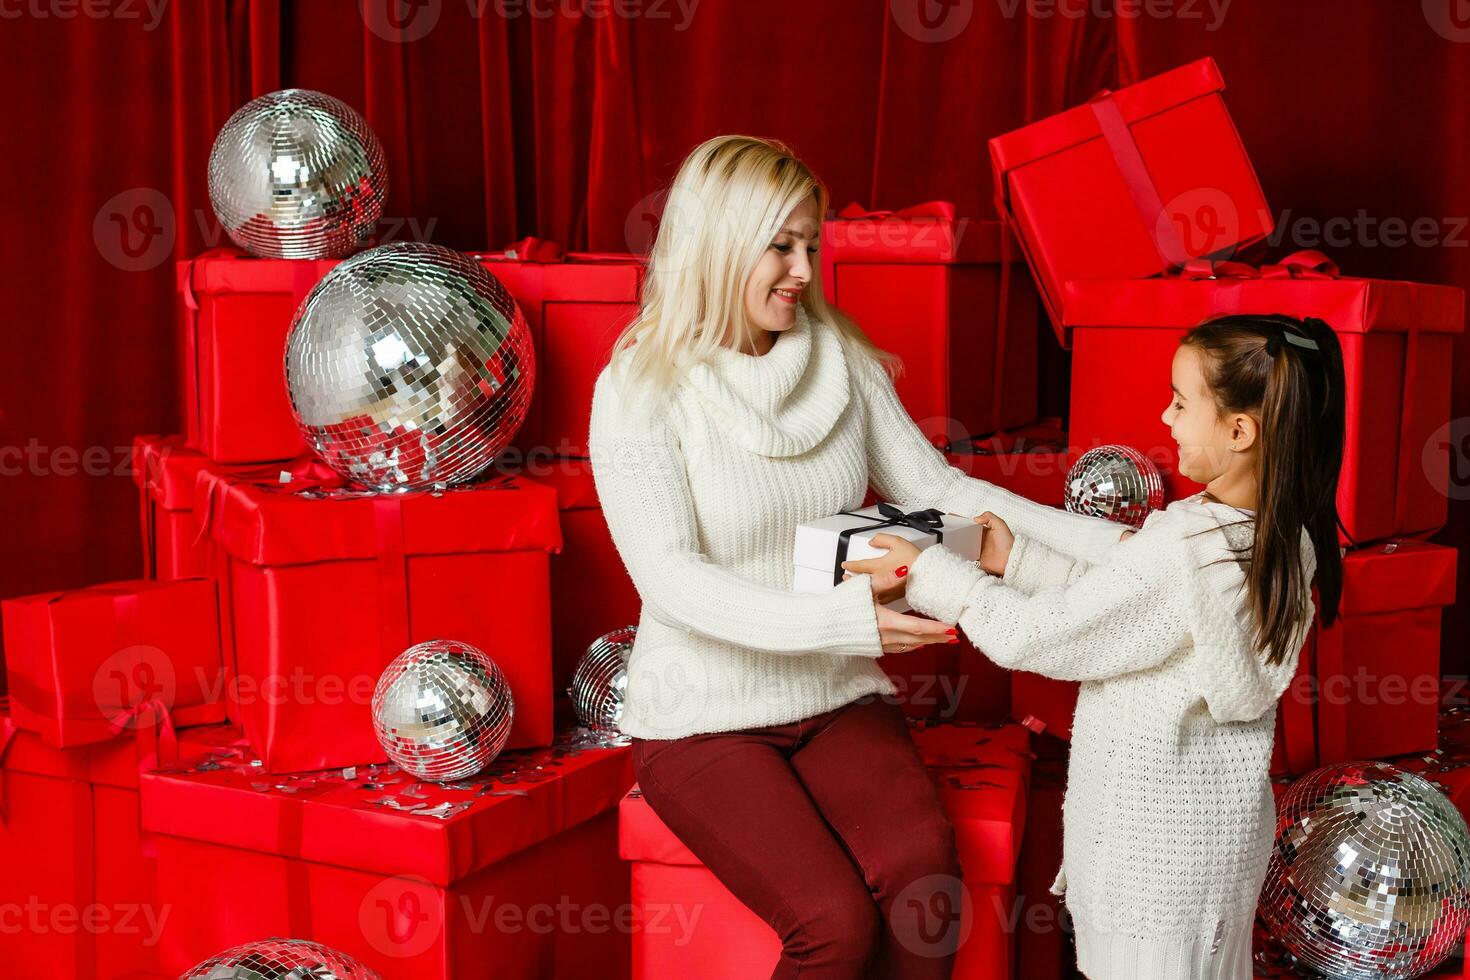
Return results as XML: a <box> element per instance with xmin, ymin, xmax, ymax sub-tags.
<box><xmin>1063</xmin><ymin>278</ymin><xmax>1466</xmax><ymax>334</ymax></box>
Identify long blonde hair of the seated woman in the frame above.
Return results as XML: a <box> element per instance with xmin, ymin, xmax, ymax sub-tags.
<box><xmin>609</xmin><ymin>135</ymin><xmax>897</xmax><ymax>411</ymax></box>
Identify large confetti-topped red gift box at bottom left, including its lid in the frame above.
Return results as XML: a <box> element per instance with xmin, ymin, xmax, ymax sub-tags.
<box><xmin>141</xmin><ymin>725</ymin><xmax>632</xmax><ymax>980</ymax></box>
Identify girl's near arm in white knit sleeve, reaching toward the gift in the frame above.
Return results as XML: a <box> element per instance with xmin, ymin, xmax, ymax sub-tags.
<box><xmin>906</xmin><ymin>520</ymin><xmax>1191</xmax><ymax>680</ymax></box>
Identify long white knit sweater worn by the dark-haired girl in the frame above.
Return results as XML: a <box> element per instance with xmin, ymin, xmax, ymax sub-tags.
<box><xmin>907</xmin><ymin>495</ymin><xmax>1316</xmax><ymax>980</ymax></box>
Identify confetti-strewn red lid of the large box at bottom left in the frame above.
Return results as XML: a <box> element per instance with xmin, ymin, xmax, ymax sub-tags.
<box><xmin>138</xmin><ymin>732</ymin><xmax>632</xmax><ymax>886</ymax></box>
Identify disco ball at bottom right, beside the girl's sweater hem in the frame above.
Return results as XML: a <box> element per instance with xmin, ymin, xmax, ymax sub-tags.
<box><xmin>1260</xmin><ymin>763</ymin><xmax>1470</xmax><ymax>980</ymax></box>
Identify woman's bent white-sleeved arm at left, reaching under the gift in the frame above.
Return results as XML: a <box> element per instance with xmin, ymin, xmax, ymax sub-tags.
<box><xmin>588</xmin><ymin>369</ymin><xmax>883</xmax><ymax>658</ymax></box>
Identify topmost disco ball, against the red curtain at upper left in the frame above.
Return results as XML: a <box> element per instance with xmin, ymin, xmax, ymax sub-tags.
<box><xmin>209</xmin><ymin>88</ymin><xmax>388</xmax><ymax>259</ymax></box>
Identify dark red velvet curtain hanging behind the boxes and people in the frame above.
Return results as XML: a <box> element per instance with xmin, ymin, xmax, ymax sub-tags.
<box><xmin>0</xmin><ymin>0</ymin><xmax>1470</xmax><ymax>673</ymax></box>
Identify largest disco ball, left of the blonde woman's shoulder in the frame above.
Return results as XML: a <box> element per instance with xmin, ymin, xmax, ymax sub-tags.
<box><xmin>285</xmin><ymin>242</ymin><xmax>537</xmax><ymax>491</ymax></box>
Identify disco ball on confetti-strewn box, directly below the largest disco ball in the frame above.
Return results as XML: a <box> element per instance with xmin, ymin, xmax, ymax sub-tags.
<box><xmin>372</xmin><ymin>639</ymin><xmax>516</xmax><ymax>782</ymax></box>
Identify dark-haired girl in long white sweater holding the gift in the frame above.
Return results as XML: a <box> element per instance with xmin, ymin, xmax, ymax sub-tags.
<box><xmin>847</xmin><ymin>316</ymin><xmax>1344</xmax><ymax>980</ymax></box>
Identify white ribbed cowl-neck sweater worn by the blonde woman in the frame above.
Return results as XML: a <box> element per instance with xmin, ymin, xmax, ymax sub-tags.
<box><xmin>588</xmin><ymin>306</ymin><xmax>1119</xmax><ymax>739</ymax></box>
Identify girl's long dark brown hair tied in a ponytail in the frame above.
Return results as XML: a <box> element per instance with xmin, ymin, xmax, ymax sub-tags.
<box><xmin>1182</xmin><ymin>314</ymin><xmax>1345</xmax><ymax>663</ymax></box>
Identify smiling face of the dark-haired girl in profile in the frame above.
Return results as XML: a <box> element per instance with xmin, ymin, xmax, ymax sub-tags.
<box><xmin>1163</xmin><ymin>345</ymin><xmax>1255</xmax><ymax>483</ymax></box>
